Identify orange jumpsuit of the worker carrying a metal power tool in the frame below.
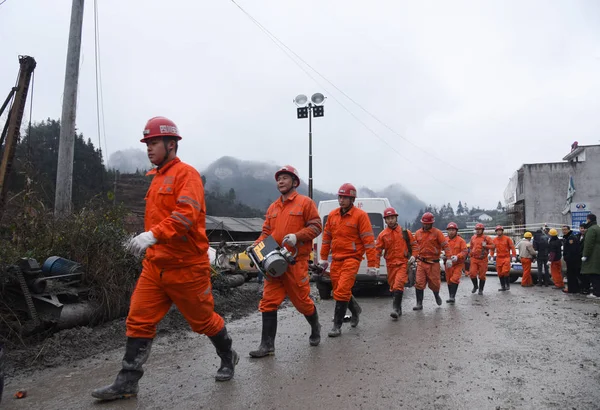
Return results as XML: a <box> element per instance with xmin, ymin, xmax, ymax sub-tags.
<box><xmin>255</xmin><ymin>192</ymin><xmax>323</xmax><ymax>316</ymax></box>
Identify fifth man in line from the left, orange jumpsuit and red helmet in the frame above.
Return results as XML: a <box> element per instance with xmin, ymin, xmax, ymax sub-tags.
<box><xmin>413</xmin><ymin>212</ymin><xmax>450</xmax><ymax>310</ymax></box>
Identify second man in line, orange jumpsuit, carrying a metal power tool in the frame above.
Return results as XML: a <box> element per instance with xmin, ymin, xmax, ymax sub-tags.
<box><xmin>250</xmin><ymin>165</ymin><xmax>323</xmax><ymax>358</ymax></box>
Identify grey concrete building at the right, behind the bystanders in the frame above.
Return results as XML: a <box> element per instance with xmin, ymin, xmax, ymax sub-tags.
<box><xmin>504</xmin><ymin>143</ymin><xmax>600</xmax><ymax>228</ymax></box>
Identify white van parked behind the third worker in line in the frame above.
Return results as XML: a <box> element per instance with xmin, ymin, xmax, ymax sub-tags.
<box><xmin>315</xmin><ymin>198</ymin><xmax>391</xmax><ymax>299</ymax></box>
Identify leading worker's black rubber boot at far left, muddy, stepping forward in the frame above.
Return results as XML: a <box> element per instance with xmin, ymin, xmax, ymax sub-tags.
<box><xmin>92</xmin><ymin>337</ymin><xmax>152</xmax><ymax>400</ymax></box>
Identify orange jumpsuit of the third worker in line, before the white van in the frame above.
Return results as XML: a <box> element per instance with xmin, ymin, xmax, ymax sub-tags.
<box><xmin>320</xmin><ymin>206</ymin><xmax>379</xmax><ymax>302</ymax></box>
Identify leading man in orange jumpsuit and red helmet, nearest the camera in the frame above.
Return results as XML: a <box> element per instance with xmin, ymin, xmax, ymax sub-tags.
<box><xmin>92</xmin><ymin>117</ymin><xmax>239</xmax><ymax>400</ymax></box>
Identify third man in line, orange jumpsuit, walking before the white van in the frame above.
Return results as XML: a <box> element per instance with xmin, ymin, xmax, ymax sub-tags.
<box><xmin>319</xmin><ymin>183</ymin><xmax>379</xmax><ymax>337</ymax></box>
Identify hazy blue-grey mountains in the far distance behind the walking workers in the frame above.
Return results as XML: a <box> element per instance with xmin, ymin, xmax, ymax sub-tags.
<box><xmin>202</xmin><ymin>157</ymin><xmax>426</xmax><ymax>224</ymax></box>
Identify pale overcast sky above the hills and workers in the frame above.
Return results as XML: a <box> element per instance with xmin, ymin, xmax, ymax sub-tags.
<box><xmin>0</xmin><ymin>0</ymin><xmax>600</xmax><ymax>207</ymax></box>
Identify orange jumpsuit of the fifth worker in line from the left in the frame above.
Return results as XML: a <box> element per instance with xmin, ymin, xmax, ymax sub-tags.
<box><xmin>413</xmin><ymin>227</ymin><xmax>450</xmax><ymax>292</ymax></box>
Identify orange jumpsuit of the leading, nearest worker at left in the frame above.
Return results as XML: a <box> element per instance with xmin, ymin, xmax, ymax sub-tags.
<box><xmin>126</xmin><ymin>158</ymin><xmax>225</xmax><ymax>338</ymax></box>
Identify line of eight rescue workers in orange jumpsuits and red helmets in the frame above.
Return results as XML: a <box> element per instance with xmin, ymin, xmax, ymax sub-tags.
<box><xmin>92</xmin><ymin>117</ymin><xmax>600</xmax><ymax>400</ymax></box>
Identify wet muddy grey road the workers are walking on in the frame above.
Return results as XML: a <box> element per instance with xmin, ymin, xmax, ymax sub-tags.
<box><xmin>2</xmin><ymin>277</ymin><xmax>600</xmax><ymax>409</ymax></box>
